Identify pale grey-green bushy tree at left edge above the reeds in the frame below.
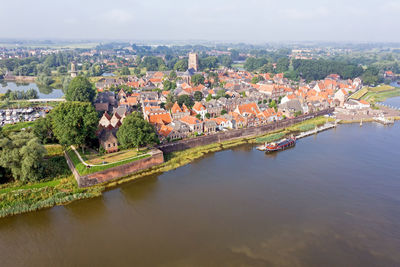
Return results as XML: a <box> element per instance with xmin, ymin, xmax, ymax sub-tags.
<box><xmin>0</xmin><ymin>132</ymin><xmax>46</xmax><ymax>183</ymax></box>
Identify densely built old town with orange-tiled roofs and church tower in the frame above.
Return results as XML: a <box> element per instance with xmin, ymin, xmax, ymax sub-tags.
<box><xmin>94</xmin><ymin>53</ymin><xmax>370</xmax><ymax>152</ymax></box>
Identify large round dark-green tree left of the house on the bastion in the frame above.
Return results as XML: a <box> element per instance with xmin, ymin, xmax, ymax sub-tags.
<box><xmin>50</xmin><ymin>102</ymin><xmax>99</xmax><ymax>148</ymax></box>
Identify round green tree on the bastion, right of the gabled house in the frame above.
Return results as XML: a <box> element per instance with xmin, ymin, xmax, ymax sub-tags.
<box><xmin>117</xmin><ymin>112</ymin><xmax>158</xmax><ymax>149</ymax></box>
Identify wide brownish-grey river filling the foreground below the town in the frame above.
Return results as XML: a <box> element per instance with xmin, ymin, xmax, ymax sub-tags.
<box><xmin>0</xmin><ymin>114</ymin><xmax>400</xmax><ymax>266</ymax></box>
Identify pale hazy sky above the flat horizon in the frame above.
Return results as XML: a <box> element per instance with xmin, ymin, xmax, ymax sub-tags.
<box><xmin>0</xmin><ymin>0</ymin><xmax>400</xmax><ymax>43</ymax></box>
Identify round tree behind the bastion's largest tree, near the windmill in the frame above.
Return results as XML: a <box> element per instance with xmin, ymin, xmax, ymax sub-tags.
<box><xmin>65</xmin><ymin>76</ymin><xmax>96</xmax><ymax>102</ymax></box>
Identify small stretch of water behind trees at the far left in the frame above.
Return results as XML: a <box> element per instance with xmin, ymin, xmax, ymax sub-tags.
<box><xmin>0</xmin><ymin>81</ymin><xmax>64</xmax><ymax>99</ymax></box>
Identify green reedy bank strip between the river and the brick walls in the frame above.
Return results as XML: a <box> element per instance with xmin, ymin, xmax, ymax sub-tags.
<box><xmin>0</xmin><ymin>117</ymin><xmax>333</xmax><ymax>218</ymax></box>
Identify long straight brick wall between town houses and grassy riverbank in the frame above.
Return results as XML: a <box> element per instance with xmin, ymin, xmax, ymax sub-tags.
<box><xmin>158</xmin><ymin>108</ymin><xmax>334</xmax><ymax>153</ymax></box>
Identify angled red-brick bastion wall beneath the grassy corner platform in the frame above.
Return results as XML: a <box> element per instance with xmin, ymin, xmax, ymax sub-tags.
<box><xmin>64</xmin><ymin>149</ymin><xmax>164</xmax><ymax>187</ymax></box>
